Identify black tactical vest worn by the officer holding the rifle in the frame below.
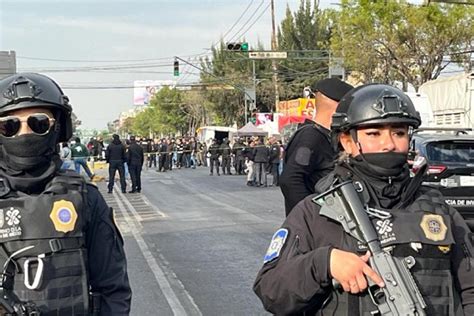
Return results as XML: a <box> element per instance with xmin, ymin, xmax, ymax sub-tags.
<box><xmin>321</xmin><ymin>189</ymin><xmax>464</xmax><ymax>316</ymax></box>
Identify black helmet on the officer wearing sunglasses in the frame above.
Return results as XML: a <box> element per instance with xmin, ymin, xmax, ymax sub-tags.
<box><xmin>0</xmin><ymin>73</ymin><xmax>72</xmax><ymax>142</ymax></box>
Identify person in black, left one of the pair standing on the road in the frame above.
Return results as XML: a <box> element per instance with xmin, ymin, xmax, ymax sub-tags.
<box><xmin>105</xmin><ymin>134</ymin><xmax>127</xmax><ymax>193</ymax></box>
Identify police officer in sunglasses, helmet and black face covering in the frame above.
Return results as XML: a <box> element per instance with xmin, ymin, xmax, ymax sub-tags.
<box><xmin>0</xmin><ymin>73</ymin><xmax>131</xmax><ymax>315</ymax></box>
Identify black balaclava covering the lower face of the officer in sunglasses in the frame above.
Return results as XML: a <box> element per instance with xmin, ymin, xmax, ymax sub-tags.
<box><xmin>0</xmin><ymin>111</ymin><xmax>61</xmax><ymax>193</ymax></box>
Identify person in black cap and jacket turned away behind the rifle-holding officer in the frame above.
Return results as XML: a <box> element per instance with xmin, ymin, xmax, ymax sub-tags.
<box><xmin>280</xmin><ymin>78</ymin><xmax>352</xmax><ymax>216</ymax></box>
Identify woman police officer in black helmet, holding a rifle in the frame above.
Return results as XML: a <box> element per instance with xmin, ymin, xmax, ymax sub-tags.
<box><xmin>254</xmin><ymin>84</ymin><xmax>474</xmax><ymax>315</ymax></box>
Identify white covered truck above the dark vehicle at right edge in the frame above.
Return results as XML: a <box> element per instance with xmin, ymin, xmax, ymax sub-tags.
<box><xmin>419</xmin><ymin>72</ymin><xmax>474</xmax><ymax>128</ymax></box>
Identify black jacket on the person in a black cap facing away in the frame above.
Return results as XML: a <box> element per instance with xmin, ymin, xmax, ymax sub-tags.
<box><xmin>280</xmin><ymin>123</ymin><xmax>336</xmax><ymax>216</ymax></box>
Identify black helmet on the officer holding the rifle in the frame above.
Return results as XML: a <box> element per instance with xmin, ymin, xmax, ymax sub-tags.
<box><xmin>331</xmin><ymin>83</ymin><xmax>421</xmax><ymax>134</ymax></box>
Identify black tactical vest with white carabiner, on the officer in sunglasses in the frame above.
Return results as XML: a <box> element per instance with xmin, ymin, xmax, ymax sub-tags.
<box><xmin>0</xmin><ymin>174</ymin><xmax>89</xmax><ymax>315</ymax></box>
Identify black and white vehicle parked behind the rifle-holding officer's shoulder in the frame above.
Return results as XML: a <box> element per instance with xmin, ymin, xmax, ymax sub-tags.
<box><xmin>412</xmin><ymin>128</ymin><xmax>474</xmax><ymax>230</ymax></box>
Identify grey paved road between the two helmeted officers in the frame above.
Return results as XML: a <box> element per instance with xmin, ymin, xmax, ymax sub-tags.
<box><xmin>99</xmin><ymin>167</ymin><xmax>284</xmax><ymax>316</ymax></box>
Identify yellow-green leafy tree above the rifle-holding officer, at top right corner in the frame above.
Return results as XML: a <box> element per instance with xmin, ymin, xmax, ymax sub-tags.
<box><xmin>331</xmin><ymin>0</ymin><xmax>474</xmax><ymax>90</ymax></box>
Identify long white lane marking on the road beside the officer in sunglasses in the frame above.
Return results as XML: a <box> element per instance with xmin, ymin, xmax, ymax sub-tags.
<box><xmin>113</xmin><ymin>190</ymin><xmax>202</xmax><ymax>316</ymax></box>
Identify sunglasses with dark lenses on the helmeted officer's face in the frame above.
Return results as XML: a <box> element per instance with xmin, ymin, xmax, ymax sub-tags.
<box><xmin>0</xmin><ymin>113</ymin><xmax>55</xmax><ymax>137</ymax></box>
